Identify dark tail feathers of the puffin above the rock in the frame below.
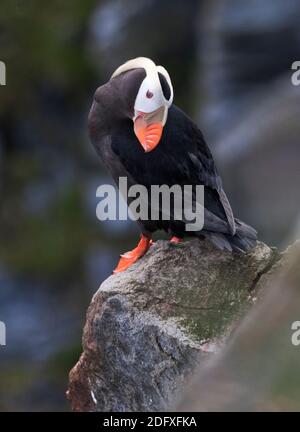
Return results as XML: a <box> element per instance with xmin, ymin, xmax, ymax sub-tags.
<box><xmin>201</xmin><ymin>219</ymin><xmax>257</xmax><ymax>252</ymax></box>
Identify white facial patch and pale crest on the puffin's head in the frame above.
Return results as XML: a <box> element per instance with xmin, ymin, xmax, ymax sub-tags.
<box><xmin>111</xmin><ymin>57</ymin><xmax>174</xmax><ymax>125</ymax></box>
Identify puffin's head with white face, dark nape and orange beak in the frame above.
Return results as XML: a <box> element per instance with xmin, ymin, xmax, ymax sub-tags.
<box><xmin>96</xmin><ymin>57</ymin><xmax>173</xmax><ymax>152</ymax></box>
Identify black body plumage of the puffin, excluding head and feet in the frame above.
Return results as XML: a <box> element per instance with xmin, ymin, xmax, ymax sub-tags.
<box><xmin>89</xmin><ymin>69</ymin><xmax>257</xmax><ymax>251</ymax></box>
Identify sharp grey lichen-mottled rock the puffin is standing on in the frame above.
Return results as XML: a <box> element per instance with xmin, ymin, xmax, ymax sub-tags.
<box><xmin>68</xmin><ymin>239</ymin><xmax>280</xmax><ymax>411</ymax></box>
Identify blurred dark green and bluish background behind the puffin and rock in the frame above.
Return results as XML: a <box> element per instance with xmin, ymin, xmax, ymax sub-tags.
<box><xmin>0</xmin><ymin>0</ymin><xmax>300</xmax><ymax>411</ymax></box>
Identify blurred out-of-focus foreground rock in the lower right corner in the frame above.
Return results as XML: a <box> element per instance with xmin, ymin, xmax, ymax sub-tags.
<box><xmin>175</xmin><ymin>241</ymin><xmax>300</xmax><ymax>412</ymax></box>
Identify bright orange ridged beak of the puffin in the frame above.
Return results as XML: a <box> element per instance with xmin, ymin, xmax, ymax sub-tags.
<box><xmin>134</xmin><ymin>112</ymin><xmax>163</xmax><ymax>152</ymax></box>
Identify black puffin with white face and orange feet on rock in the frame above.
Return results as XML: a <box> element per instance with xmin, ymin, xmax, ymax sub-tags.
<box><xmin>88</xmin><ymin>57</ymin><xmax>257</xmax><ymax>273</ymax></box>
